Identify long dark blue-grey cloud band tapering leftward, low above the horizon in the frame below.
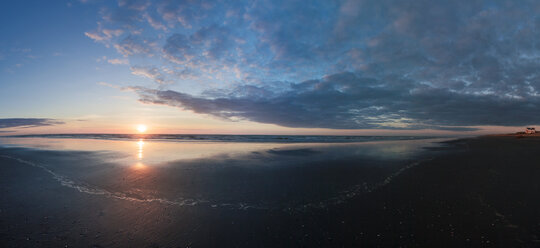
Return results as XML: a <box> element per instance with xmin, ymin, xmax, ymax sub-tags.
<box><xmin>127</xmin><ymin>73</ymin><xmax>540</xmax><ymax>131</ymax></box>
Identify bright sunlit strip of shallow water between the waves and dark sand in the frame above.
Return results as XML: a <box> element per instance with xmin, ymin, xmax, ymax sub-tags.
<box><xmin>0</xmin><ymin>137</ymin><xmax>452</xmax><ymax>169</ymax></box>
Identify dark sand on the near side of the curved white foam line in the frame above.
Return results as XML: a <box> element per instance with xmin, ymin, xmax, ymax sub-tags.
<box><xmin>0</xmin><ymin>136</ymin><xmax>540</xmax><ymax>247</ymax></box>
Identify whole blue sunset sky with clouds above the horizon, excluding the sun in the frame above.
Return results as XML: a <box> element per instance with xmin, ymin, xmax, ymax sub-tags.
<box><xmin>0</xmin><ymin>0</ymin><xmax>540</xmax><ymax>135</ymax></box>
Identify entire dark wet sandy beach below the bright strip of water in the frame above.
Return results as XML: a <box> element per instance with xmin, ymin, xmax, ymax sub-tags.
<box><xmin>0</xmin><ymin>136</ymin><xmax>540</xmax><ymax>247</ymax></box>
